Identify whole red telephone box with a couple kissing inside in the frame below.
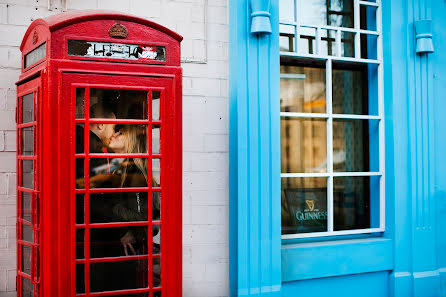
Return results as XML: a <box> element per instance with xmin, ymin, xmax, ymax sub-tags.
<box><xmin>17</xmin><ymin>11</ymin><xmax>182</xmax><ymax>297</ymax></box>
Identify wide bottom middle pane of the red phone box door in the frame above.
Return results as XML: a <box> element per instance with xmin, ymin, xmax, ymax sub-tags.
<box><xmin>90</xmin><ymin>259</ymin><xmax>149</xmax><ymax>292</ymax></box>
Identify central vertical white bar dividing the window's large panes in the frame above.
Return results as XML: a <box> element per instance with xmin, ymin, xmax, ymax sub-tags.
<box><xmin>325</xmin><ymin>59</ymin><xmax>334</xmax><ymax>232</ymax></box>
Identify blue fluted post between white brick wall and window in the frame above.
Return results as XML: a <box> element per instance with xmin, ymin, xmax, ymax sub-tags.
<box><xmin>229</xmin><ymin>0</ymin><xmax>281</xmax><ymax>297</ymax></box>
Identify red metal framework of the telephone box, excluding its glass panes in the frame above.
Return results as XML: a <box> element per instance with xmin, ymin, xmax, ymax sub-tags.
<box><xmin>17</xmin><ymin>11</ymin><xmax>182</xmax><ymax>297</ymax></box>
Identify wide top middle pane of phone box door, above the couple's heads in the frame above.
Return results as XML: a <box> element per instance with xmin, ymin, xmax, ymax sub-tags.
<box><xmin>89</xmin><ymin>89</ymin><xmax>149</xmax><ymax>120</ymax></box>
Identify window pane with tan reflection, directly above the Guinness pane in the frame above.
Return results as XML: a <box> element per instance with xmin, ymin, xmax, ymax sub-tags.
<box><xmin>280</xmin><ymin>118</ymin><xmax>327</xmax><ymax>173</ymax></box>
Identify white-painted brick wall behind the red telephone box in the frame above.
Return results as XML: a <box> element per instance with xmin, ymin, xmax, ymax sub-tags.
<box><xmin>0</xmin><ymin>0</ymin><xmax>229</xmax><ymax>297</ymax></box>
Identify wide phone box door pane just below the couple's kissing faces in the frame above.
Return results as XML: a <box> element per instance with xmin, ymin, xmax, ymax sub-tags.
<box><xmin>90</xmin><ymin>158</ymin><xmax>148</xmax><ymax>188</ymax></box>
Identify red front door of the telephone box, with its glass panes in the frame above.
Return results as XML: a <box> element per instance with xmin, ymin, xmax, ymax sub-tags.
<box><xmin>60</xmin><ymin>73</ymin><xmax>181</xmax><ymax>297</ymax></box>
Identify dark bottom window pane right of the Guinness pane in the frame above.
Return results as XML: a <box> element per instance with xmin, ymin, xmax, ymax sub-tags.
<box><xmin>333</xmin><ymin>176</ymin><xmax>376</xmax><ymax>231</ymax></box>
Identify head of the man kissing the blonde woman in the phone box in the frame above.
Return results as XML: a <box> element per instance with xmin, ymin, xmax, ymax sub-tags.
<box><xmin>90</xmin><ymin>103</ymin><xmax>116</xmax><ymax>146</ymax></box>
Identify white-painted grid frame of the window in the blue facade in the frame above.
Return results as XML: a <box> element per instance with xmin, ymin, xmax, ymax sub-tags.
<box><xmin>279</xmin><ymin>0</ymin><xmax>385</xmax><ymax>239</ymax></box>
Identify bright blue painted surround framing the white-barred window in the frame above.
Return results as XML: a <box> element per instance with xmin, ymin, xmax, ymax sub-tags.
<box><xmin>229</xmin><ymin>0</ymin><xmax>446</xmax><ymax>297</ymax></box>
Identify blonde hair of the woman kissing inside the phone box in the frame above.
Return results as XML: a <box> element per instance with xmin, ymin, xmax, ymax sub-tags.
<box><xmin>121</xmin><ymin>125</ymin><xmax>149</xmax><ymax>187</ymax></box>
